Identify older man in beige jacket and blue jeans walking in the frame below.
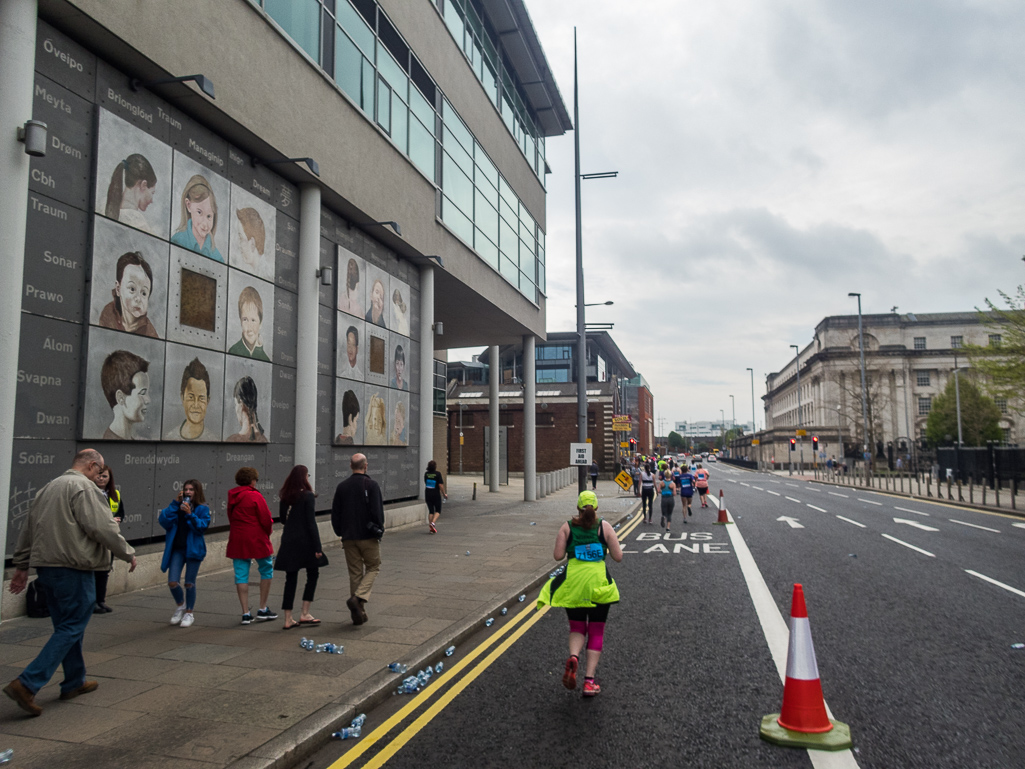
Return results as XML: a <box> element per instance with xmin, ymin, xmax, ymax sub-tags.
<box><xmin>4</xmin><ymin>449</ymin><xmax>135</xmax><ymax>716</ymax></box>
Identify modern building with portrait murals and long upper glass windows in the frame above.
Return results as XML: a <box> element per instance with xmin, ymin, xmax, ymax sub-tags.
<box><xmin>0</xmin><ymin>0</ymin><xmax>572</xmax><ymax>554</ymax></box>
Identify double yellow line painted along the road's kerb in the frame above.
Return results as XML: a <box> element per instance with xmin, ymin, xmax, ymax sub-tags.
<box><xmin>328</xmin><ymin>508</ymin><xmax>641</xmax><ymax>769</ymax></box>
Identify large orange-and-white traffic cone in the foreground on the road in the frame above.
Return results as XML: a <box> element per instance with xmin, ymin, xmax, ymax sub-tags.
<box><xmin>759</xmin><ymin>583</ymin><xmax>851</xmax><ymax>751</ymax></box>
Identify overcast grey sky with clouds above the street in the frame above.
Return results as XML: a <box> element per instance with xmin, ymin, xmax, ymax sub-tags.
<box><xmin>463</xmin><ymin>0</ymin><xmax>1025</xmax><ymax>431</ymax></box>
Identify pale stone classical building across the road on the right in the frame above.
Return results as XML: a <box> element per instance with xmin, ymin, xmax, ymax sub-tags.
<box><xmin>735</xmin><ymin>313</ymin><xmax>1022</xmax><ymax>464</ymax></box>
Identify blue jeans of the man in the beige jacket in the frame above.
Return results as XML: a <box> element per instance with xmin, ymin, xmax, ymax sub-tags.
<box><xmin>17</xmin><ymin>566</ymin><xmax>96</xmax><ymax>694</ymax></box>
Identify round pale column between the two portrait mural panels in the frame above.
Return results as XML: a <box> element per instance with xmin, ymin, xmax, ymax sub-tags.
<box><xmin>294</xmin><ymin>185</ymin><xmax>319</xmax><ymax>479</ymax></box>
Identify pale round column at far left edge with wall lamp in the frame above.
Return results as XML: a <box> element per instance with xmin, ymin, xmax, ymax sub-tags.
<box><xmin>0</xmin><ymin>0</ymin><xmax>38</xmax><ymax>582</ymax></box>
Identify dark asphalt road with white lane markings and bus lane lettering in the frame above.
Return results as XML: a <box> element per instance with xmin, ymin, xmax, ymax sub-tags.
<box><xmin>297</xmin><ymin>464</ymin><xmax>1025</xmax><ymax>769</ymax></box>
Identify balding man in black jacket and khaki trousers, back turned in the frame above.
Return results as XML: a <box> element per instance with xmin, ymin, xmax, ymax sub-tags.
<box><xmin>331</xmin><ymin>454</ymin><xmax>384</xmax><ymax>624</ymax></box>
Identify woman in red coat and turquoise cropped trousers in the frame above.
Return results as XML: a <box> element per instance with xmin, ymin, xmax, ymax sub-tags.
<box><xmin>224</xmin><ymin>468</ymin><xmax>278</xmax><ymax>624</ymax></box>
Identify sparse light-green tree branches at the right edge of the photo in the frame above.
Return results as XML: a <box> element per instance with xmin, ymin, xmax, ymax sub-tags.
<box><xmin>966</xmin><ymin>286</ymin><xmax>1025</xmax><ymax>410</ymax></box>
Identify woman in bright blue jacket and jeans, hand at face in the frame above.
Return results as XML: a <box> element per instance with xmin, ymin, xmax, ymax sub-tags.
<box><xmin>159</xmin><ymin>480</ymin><xmax>210</xmax><ymax>628</ymax></box>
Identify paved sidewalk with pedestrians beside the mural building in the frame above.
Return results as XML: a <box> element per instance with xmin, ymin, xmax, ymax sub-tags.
<box><xmin>0</xmin><ymin>476</ymin><xmax>637</xmax><ymax>769</ymax></box>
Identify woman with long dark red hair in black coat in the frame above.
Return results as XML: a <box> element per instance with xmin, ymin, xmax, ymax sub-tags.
<box><xmin>274</xmin><ymin>464</ymin><xmax>322</xmax><ymax>631</ymax></box>
